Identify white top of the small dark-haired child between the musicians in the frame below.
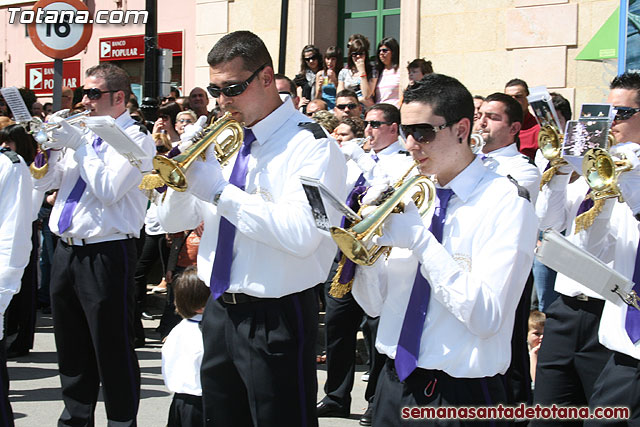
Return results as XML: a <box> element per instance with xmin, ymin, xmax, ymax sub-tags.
<box><xmin>162</xmin><ymin>314</ymin><xmax>204</xmax><ymax>396</ymax></box>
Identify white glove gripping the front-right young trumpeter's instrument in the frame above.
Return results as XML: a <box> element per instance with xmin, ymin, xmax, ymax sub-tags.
<box><xmin>373</xmin><ymin>201</ymin><xmax>430</xmax><ymax>250</ymax></box>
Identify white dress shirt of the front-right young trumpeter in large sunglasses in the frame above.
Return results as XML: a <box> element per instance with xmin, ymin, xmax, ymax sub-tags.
<box><xmin>352</xmin><ymin>158</ymin><xmax>537</xmax><ymax>378</ymax></box>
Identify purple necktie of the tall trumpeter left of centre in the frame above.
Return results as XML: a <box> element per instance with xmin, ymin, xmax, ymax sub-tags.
<box><xmin>210</xmin><ymin>128</ymin><xmax>256</xmax><ymax>300</ymax></box>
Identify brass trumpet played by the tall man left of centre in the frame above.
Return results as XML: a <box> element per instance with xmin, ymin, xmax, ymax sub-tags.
<box><xmin>139</xmin><ymin>112</ymin><xmax>244</xmax><ymax>192</ymax></box>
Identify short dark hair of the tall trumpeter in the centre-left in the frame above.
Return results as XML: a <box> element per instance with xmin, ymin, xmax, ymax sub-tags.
<box><xmin>207</xmin><ymin>31</ymin><xmax>273</xmax><ymax>72</ymax></box>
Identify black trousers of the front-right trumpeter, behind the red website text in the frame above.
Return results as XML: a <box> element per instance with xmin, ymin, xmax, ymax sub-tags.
<box><xmin>373</xmin><ymin>359</ymin><xmax>508</xmax><ymax>427</ymax></box>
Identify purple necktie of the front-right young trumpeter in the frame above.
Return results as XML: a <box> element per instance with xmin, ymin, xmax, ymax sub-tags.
<box><xmin>395</xmin><ymin>188</ymin><xmax>453</xmax><ymax>381</ymax></box>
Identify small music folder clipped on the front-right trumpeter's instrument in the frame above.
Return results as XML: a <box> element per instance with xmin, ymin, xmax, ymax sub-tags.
<box><xmin>300</xmin><ymin>176</ymin><xmax>362</xmax><ymax>234</ymax></box>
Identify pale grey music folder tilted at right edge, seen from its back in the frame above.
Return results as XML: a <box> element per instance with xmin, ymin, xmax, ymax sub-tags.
<box><xmin>536</xmin><ymin>230</ymin><xmax>633</xmax><ymax>304</ymax></box>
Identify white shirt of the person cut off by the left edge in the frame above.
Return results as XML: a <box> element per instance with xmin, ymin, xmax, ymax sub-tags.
<box><xmin>0</xmin><ymin>153</ymin><xmax>32</xmax><ymax>339</ymax></box>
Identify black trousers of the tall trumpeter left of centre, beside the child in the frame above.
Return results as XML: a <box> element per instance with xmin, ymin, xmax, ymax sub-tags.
<box><xmin>200</xmin><ymin>288</ymin><xmax>318</xmax><ymax>427</ymax></box>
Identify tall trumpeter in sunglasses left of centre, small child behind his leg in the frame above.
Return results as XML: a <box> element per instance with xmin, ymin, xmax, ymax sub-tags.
<box><xmin>158</xmin><ymin>31</ymin><xmax>346</xmax><ymax>427</ymax></box>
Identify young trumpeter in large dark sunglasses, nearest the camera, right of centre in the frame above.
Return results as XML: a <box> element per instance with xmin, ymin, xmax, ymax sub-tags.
<box><xmin>352</xmin><ymin>74</ymin><xmax>537</xmax><ymax>426</ymax></box>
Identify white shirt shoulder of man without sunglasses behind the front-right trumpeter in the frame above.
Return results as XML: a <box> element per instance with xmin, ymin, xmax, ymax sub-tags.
<box><xmin>479</xmin><ymin>143</ymin><xmax>542</xmax><ymax>205</ymax></box>
